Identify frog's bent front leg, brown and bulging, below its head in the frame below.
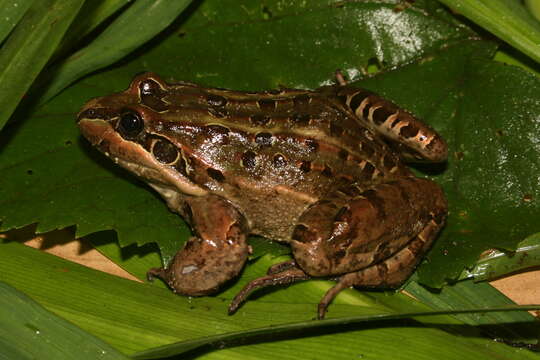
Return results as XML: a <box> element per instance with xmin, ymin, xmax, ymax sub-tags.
<box><xmin>147</xmin><ymin>196</ymin><xmax>248</xmax><ymax>296</ymax></box>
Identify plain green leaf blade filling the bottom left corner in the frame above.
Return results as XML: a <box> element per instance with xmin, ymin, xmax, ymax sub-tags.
<box><xmin>0</xmin><ymin>282</ymin><xmax>128</xmax><ymax>360</ymax></box>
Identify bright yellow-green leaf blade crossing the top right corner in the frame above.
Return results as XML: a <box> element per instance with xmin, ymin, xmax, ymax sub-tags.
<box><xmin>439</xmin><ymin>0</ymin><xmax>540</xmax><ymax>62</ymax></box>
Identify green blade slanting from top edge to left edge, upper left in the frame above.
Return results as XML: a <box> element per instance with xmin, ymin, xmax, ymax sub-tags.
<box><xmin>0</xmin><ymin>0</ymin><xmax>84</xmax><ymax>129</ymax></box>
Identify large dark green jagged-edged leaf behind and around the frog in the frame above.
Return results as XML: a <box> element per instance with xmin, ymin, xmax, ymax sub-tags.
<box><xmin>0</xmin><ymin>1</ymin><xmax>540</xmax><ymax>296</ymax></box>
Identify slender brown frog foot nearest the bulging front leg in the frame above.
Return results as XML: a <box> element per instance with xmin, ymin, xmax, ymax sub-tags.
<box><xmin>229</xmin><ymin>263</ymin><xmax>311</xmax><ymax>315</ymax></box>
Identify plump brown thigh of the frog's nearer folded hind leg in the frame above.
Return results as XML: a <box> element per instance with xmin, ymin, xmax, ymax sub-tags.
<box><xmin>291</xmin><ymin>177</ymin><xmax>446</xmax><ymax>278</ymax></box>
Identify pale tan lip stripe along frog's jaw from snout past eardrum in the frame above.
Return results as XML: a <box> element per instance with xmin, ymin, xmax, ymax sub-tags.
<box><xmin>78</xmin><ymin>118</ymin><xmax>208</xmax><ymax>196</ymax></box>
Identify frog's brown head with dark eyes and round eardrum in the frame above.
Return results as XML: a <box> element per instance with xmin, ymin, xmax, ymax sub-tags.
<box><xmin>77</xmin><ymin>73</ymin><xmax>205</xmax><ymax>208</ymax></box>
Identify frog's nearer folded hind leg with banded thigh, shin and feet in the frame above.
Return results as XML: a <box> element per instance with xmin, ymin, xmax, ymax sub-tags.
<box><xmin>230</xmin><ymin>177</ymin><xmax>446</xmax><ymax>317</ymax></box>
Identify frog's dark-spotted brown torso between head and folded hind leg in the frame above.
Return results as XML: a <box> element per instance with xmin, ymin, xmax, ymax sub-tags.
<box><xmin>142</xmin><ymin>84</ymin><xmax>407</xmax><ymax>239</ymax></box>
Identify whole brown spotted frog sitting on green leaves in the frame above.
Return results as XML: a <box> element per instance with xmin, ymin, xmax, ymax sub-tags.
<box><xmin>77</xmin><ymin>72</ymin><xmax>448</xmax><ymax>319</ymax></box>
